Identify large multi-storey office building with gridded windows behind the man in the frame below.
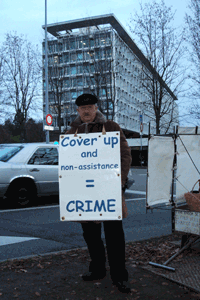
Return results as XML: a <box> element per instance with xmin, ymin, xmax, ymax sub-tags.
<box><xmin>43</xmin><ymin>14</ymin><xmax>178</xmax><ymax>136</ymax></box>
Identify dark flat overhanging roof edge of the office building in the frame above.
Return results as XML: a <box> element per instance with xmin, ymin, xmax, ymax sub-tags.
<box><xmin>42</xmin><ymin>14</ymin><xmax>177</xmax><ymax>100</ymax></box>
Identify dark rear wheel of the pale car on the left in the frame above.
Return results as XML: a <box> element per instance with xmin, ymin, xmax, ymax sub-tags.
<box><xmin>8</xmin><ymin>181</ymin><xmax>36</xmax><ymax>207</ymax></box>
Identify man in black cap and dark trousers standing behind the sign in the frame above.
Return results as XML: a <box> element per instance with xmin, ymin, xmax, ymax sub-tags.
<box><xmin>67</xmin><ymin>94</ymin><xmax>131</xmax><ymax>293</ymax></box>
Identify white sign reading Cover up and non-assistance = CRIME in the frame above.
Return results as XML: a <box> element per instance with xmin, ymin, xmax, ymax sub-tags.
<box><xmin>59</xmin><ymin>131</ymin><xmax>122</xmax><ymax>221</ymax></box>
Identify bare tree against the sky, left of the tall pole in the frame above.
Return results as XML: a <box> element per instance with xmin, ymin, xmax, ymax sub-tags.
<box><xmin>1</xmin><ymin>33</ymin><xmax>42</xmax><ymax>139</ymax></box>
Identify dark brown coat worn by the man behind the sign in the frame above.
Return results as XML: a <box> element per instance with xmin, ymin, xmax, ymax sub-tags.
<box><xmin>67</xmin><ymin>111</ymin><xmax>132</xmax><ymax>218</ymax></box>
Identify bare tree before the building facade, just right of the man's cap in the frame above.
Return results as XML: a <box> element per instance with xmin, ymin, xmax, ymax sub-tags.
<box><xmin>79</xmin><ymin>27</ymin><xmax>116</xmax><ymax>120</ymax></box>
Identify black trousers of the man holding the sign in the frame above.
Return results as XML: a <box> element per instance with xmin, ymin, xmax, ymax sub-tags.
<box><xmin>81</xmin><ymin>221</ymin><xmax>128</xmax><ymax>281</ymax></box>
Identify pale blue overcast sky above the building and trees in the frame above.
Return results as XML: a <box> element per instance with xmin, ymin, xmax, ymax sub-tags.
<box><xmin>0</xmin><ymin>0</ymin><xmax>193</xmax><ymax>124</ymax></box>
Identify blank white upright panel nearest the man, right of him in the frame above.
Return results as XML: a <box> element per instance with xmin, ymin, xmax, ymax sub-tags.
<box><xmin>147</xmin><ymin>136</ymin><xmax>174</xmax><ymax>206</ymax></box>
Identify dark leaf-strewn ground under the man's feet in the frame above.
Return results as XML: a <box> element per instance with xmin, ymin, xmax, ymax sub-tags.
<box><xmin>0</xmin><ymin>234</ymin><xmax>200</xmax><ymax>300</ymax></box>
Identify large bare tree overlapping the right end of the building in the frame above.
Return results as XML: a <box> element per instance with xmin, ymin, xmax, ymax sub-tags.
<box><xmin>129</xmin><ymin>0</ymin><xmax>185</xmax><ymax>134</ymax></box>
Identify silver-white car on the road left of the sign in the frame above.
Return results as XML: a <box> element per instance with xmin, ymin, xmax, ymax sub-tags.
<box><xmin>0</xmin><ymin>143</ymin><xmax>59</xmax><ymax>206</ymax></box>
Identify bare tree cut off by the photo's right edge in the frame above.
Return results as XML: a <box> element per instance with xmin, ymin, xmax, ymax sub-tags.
<box><xmin>185</xmin><ymin>0</ymin><xmax>200</xmax><ymax>123</ymax></box>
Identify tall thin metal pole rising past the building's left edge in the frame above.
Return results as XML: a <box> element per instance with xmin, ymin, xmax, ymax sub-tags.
<box><xmin>45</xmin><ymin>0</ymin><xmax>49</xmax><ymax>144</ymax></box>
